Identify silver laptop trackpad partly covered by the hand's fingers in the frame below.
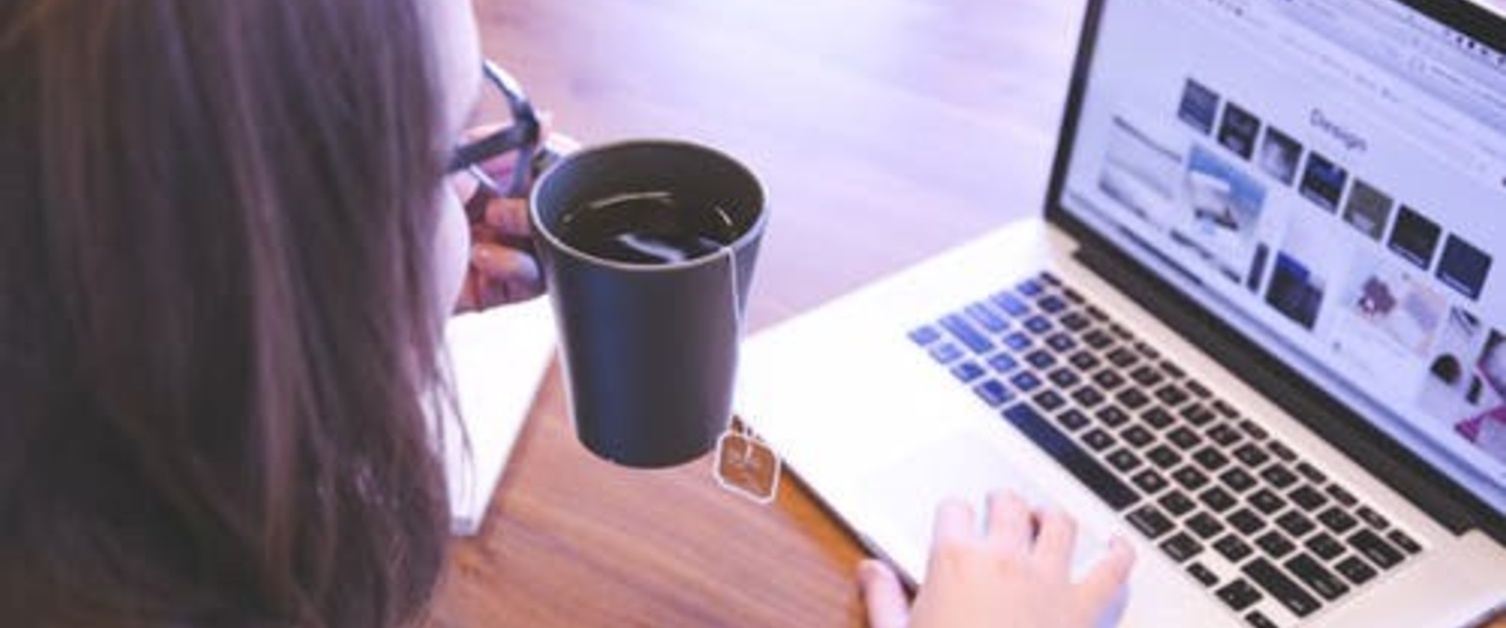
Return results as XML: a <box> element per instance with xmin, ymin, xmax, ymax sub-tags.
<box><xmin>857</xmin><ymin>437</ymin><xmax>1107</xmax><ymax>583</ymax></box>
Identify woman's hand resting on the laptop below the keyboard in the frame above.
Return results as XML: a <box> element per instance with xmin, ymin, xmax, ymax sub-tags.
<box><xmin>858</xmin><ymin>492</ymin><xmax>1134</xmax><ymax>628</ymax></box>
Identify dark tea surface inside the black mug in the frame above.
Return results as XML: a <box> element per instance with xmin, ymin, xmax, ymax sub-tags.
<box><xmin>559</xmin><ymin>191</ymin><xmax>738</xmax><ymax>264</ymax></box>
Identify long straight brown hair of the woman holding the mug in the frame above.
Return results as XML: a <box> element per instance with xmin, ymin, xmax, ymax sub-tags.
<box><xmin>0</xmin><ymin>0</ymin><xmax>447</xmax><ymax>626</ymax></box>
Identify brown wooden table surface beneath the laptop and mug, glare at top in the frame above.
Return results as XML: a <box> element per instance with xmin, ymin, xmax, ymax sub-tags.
<box><xmin>432</xmin><ymin>0</ymin><xmax>1499</xmax><ymax>626</ymax></box>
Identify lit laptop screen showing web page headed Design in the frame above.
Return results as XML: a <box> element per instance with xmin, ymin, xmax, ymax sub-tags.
<box><xmin>1056</xmin><ymin>0</ymin><xmax>1506</xmax><ymax>512</ymax></box>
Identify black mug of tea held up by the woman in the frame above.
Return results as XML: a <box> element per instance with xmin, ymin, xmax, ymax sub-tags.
<box><xmin>529</xmin><ymin>140</ymin><xmax>768</xmax><ymax>467</ymax></box>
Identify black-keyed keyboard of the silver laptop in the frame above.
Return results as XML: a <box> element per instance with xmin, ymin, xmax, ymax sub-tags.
<box><xmin>910</xmin><ymin>273</ymin><xmax>1422</xmax><ymax>628</ymax></box>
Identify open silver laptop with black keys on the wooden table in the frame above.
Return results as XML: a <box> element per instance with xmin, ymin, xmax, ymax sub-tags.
<box><xmin>738</xmin><ymin>0</ymin><xmax>1506</xmax><ymax>626</ymax></box>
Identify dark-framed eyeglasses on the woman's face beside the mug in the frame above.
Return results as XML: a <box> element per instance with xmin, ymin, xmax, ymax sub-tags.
<box><xmin>446</xmin><ymin>60</ymin><xmax>542</xmax><ymax>197</ymax></box>
